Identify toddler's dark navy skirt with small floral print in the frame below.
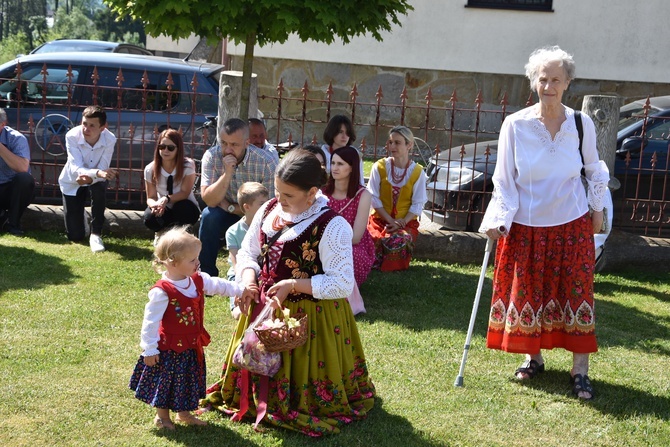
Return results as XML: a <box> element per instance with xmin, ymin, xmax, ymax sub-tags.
<box><xmin>129</xmin><ymin>349</ymin><xmax>207</xmax><ymax>412</ymax></box>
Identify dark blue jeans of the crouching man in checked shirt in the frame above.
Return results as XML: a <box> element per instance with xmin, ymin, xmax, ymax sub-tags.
<box><xmin>198</xmin><ymin>206</ymin><xmax>240</xmax><ymax>276</ymax></box>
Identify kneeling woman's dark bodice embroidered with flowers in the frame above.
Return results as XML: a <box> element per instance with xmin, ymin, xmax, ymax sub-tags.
<box><xmin>260</xmin><ymin>199</ymin><xmax>338</xmax><ymax>303</ymax></box>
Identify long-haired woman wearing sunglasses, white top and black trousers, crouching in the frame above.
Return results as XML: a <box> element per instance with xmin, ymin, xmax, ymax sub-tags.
<box><xmin>144</xmin><ymin>129</ymin><xmax>200</xmax><ymax>244</ymax></box>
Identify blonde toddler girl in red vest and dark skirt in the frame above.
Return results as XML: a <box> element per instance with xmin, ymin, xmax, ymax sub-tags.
<box><xmin>129</xmin><ymin>228</ymin><xmax>257</xmax><ymax>430</ymax></box>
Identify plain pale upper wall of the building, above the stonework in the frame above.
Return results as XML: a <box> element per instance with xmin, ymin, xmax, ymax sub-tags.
<box><xmin>228</xmin><ymin>0</ymin><xmax>670</xmax><ymax>83</ymax></box>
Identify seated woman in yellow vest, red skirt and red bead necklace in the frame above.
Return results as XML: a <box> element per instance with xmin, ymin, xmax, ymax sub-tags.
<box><xmin>368</xmin><ymin>126</ymin><xmax>426</xmax><ymax>271</ymax></box>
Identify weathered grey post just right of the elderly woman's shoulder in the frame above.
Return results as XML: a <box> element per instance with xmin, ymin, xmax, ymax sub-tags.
<box><xmin>582</xmin><ymin>95</ymin><xmax>620</xmax><ymax>190</ymax></box>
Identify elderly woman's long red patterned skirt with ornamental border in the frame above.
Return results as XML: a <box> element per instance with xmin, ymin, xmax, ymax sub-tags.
<box><xmin>486</xmin><ymin>214</ymin><xmax>598</xmax><ymax>354</ymax></box>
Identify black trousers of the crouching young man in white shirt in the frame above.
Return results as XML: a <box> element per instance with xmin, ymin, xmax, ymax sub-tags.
<box><xmin>63</xmin><ymin>181</ymin><xmax>107</xmax><ymax>242</ymax></box>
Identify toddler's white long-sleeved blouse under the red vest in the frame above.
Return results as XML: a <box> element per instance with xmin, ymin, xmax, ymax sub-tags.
<box><xmin>140</xmin><ymin>272</ymin><xmax>243</xmax><ymax>357</ymax></box>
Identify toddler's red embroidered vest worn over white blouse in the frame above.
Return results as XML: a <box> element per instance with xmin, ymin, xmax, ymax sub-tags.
<box><xmin>154</xmin><ymin>273</ymin><xmax>210</xmax><ymax>361</ymax></box>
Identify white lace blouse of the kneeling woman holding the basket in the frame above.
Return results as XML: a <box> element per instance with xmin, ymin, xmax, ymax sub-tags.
<box><xmin>236</xmin><ymin>192</ymin><xmax>356</xmax><ymax>299</ymax></box>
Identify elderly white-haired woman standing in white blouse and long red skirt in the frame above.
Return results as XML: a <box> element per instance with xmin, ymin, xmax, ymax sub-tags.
<box><xmin>479</xmin><ymin>46</ymin><xmax>609</xmax><ymax>399</ymax></box>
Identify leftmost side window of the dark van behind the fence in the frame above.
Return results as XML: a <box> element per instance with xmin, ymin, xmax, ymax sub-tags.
<box><xmin>0</xmin><ymin>64</ymin><xmax>81</xmax><ymax>108</ymax></box>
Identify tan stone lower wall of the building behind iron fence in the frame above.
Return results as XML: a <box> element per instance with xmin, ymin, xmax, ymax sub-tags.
<box><xmin>229</xmin><ymin>56</ymin><xmax>670</xmax><ymax>149</ymax></box>
